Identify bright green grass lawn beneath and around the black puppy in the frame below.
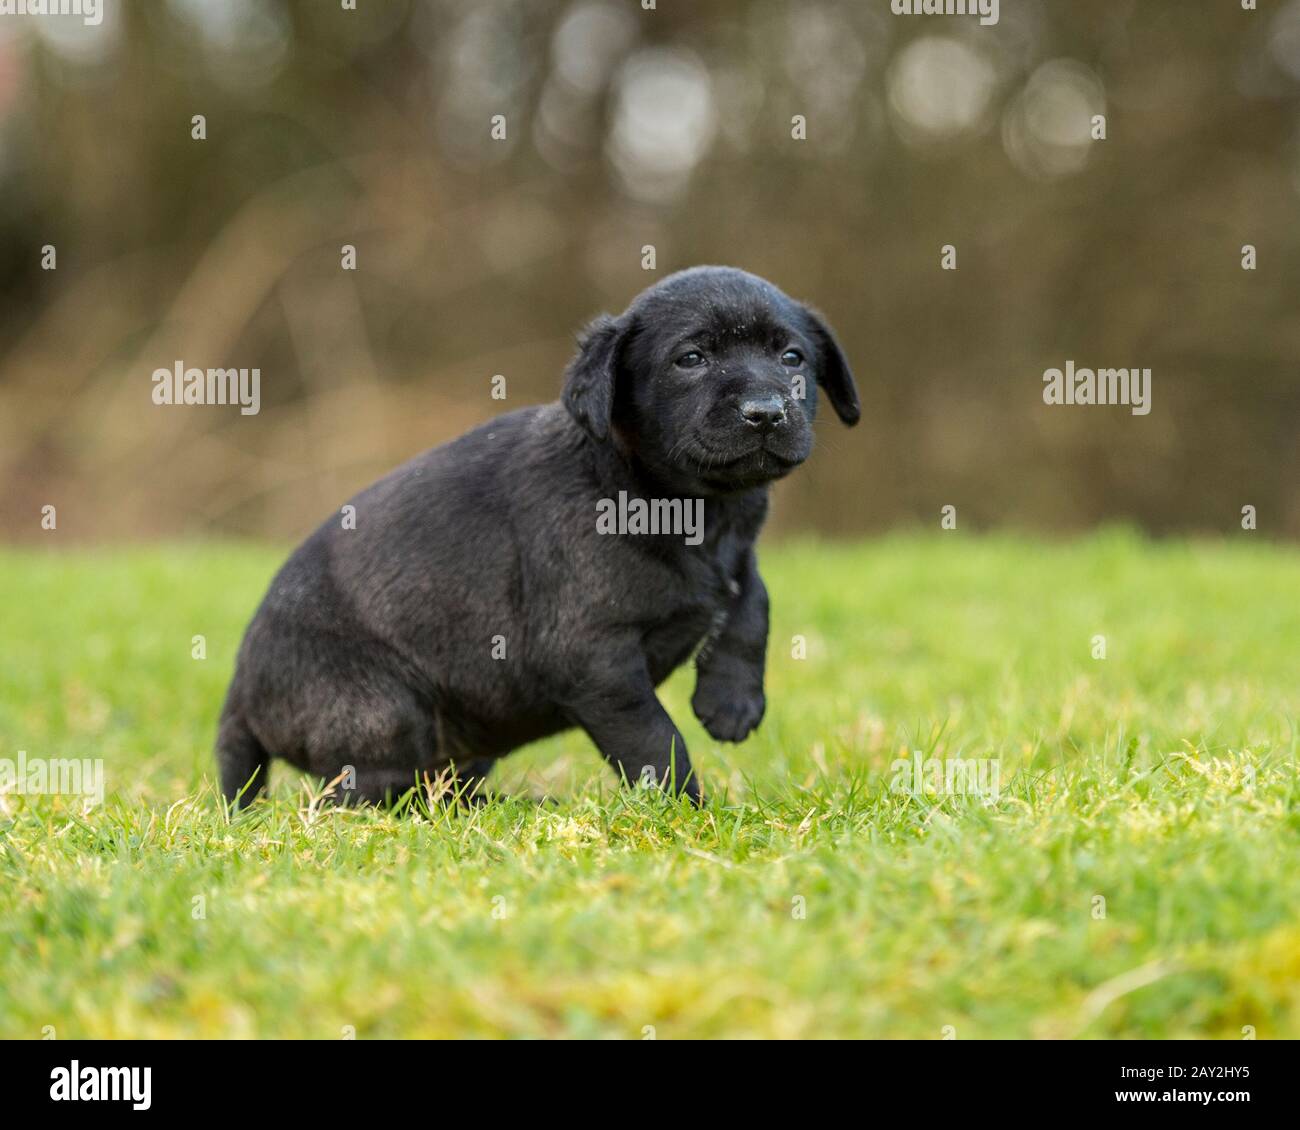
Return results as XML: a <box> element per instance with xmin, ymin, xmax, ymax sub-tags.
<box><xmin>0</xmin><ymin>532</ymin><xmax>1300</xmax><ymax>1039</ymax></box>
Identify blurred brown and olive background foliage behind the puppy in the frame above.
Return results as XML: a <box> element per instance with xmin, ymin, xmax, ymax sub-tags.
<box><xmin>0</xmin><ymin>0</ymin><xmax>1300</xmax><ymax>542</ymax></box>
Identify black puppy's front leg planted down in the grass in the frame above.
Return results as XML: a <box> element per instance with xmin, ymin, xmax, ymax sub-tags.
<box><xmin>571</xmin><ymin>657</ymin><xmax>701</xmax><ymax>804</ymax></box>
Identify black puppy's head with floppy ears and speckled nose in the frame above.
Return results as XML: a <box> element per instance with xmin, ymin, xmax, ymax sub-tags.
<box><xmin>562</xmin><ymin>267</ymin><xmax>859</xmax><ymax>494</ymax></box>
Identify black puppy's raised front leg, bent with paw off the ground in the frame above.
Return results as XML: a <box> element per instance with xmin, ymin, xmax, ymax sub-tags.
<box><xmin>690</xmin><ymin>551</ymin><xmax>767</xmax><ymax>741</ymax></box>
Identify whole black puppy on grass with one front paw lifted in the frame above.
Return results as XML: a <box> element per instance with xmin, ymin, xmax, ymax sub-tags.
<box><xmin>217</xmin><ymin>267</ymin><xmax>859</xmax><ymax>801</ymax></box>
